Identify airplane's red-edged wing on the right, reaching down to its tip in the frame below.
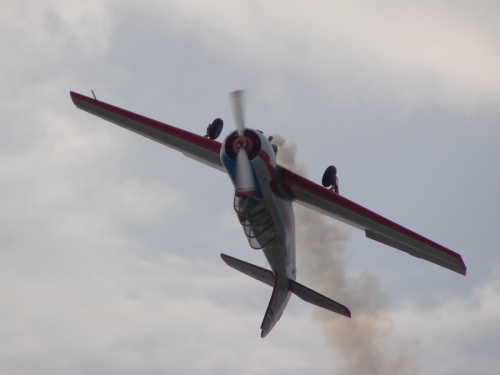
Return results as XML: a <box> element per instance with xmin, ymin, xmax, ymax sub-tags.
<box><xmin>276</xmin><ymin>166</ymin><xmax>467</xmax><ymax>275</ymax></box>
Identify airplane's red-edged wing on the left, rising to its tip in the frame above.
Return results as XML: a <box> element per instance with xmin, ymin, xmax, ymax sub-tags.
<box><xmin>70</xmin><ymin>91</ymin><xmax>225</xmax><ymax>172</ymax></box>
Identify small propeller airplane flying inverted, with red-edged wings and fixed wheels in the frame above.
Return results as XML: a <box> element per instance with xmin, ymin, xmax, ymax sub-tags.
<box><xmin>70</xmin><ymin>91</ymin><xmax>466</xmax><ymax>338</ymax></box>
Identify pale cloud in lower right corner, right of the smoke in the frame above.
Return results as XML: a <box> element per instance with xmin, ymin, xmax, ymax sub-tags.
<box><xmin>391</xmin><ymin>270</ymin><xmax>500</xmax><ymax>375</ymax></box>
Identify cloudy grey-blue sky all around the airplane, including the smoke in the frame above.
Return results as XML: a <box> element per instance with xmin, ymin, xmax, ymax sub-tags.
<box><xmin>0</xmin><ymin>0</ymin><xmax>500</xmax><ymax>375</ymax></box>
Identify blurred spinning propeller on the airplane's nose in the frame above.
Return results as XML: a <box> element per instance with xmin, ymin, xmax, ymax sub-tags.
<box><xmin>231</xmin><ymin>90</ymin><xmax>255</xmax><ymax>195</ymax></box>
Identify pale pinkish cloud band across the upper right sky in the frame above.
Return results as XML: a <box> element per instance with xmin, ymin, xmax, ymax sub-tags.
<box><xmin>146</xmin><ymin>2</ymin><xmax>500</xmax><ymax>113</ymax></box>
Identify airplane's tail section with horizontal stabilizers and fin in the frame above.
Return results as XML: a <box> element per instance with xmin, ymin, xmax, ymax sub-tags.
<box><xmin>220</xmin><ymin>254</ymin><xmax>351</xmax><ymax>337</ymax></box>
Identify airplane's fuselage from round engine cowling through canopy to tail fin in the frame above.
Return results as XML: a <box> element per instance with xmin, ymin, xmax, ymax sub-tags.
<box><xmin>221</xmin><ymin>129</ymin><xmax>297</xmax><ymax>336</ymax></box>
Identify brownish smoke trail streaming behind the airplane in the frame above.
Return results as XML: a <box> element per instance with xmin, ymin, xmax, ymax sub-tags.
<box><xmin>273</xmin><ymin>135</ymin><xmax>418</xmax><ymax>375</ymax></box>
